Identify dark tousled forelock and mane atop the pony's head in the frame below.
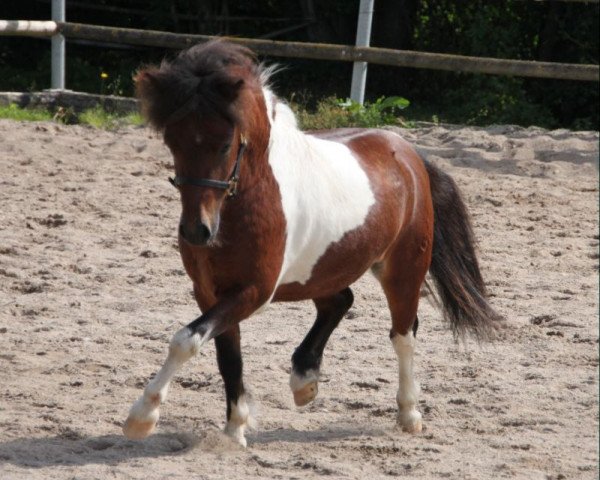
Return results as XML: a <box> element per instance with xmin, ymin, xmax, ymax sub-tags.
<box><xmin>135</xmin><ymin>40</ymin><xmax>260</xmax><ymax>130</ymax></box>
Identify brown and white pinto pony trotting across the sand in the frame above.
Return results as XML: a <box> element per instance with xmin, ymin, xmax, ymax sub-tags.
<box><xmin>123</xmin><ymin>41</ymin><xmax>498</xmax><ymax>445</ymax></box>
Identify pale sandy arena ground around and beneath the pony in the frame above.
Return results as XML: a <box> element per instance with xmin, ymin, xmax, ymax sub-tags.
<box><xmin>0</xmin><ymin>120</ymin><xmax>599</xmax><ymax>480</ymax></box>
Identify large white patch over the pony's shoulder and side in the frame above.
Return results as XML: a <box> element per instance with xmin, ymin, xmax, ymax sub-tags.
<box><xmin>264</xmin><ymin>89</ymin><xmax>375</xmax><ymax>285</ymax></box>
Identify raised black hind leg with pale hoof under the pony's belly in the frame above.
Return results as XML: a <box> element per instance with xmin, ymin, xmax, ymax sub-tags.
<box><xmin>290</xmin><ymin>288</ymin><xmax>354</xmax><ymax>407</ymax></box>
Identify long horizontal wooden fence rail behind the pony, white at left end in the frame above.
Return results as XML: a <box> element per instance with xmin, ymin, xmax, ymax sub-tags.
<box><xmin>0</xmin><ymin>20</ymin><xmax>600</xmax><ymax>82</ymax></box>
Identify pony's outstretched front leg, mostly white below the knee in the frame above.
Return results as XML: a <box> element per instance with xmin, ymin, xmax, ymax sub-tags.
<box><xmin>123</xmin><ymin>289</ymin><xmax>268</xmax><ymax>440</ymax></box>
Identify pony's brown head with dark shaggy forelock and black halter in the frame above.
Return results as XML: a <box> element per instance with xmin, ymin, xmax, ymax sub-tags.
<box><xmin>135</xmin><ymin>41</ymin><xmax>269</xmax><ymax>246</ymax></box>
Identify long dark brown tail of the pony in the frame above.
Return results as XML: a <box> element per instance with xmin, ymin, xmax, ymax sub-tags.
<box><xmin>424</xmin><ymin>156</ymin><xmax>502</xmax><ymax>339</ymax></box>
